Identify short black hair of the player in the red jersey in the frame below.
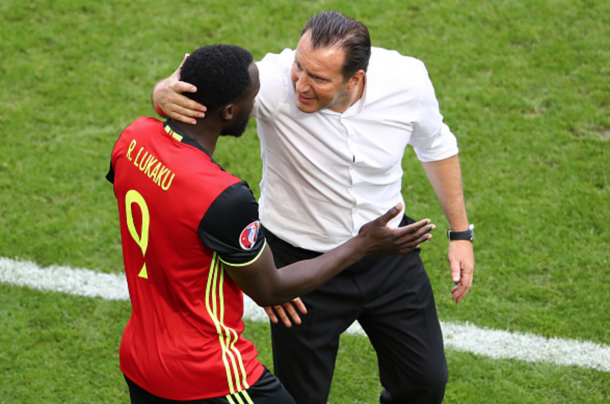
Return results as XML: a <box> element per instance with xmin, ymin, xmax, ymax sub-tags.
<box><xmin>180</xmin><ymin>44</ymin><xmax>254</xmax><ymax>112</ymax></box>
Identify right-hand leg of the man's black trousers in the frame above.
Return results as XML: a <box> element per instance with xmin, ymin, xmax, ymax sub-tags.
<box><xmin>358</xmin><ymin>251</ymin><xmax>447</xmax><ymax>402</ymax></box>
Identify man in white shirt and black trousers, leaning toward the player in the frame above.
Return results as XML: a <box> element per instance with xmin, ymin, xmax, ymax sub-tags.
<box><xmin>153</xmin><ymin>11</ymin><xmax>474</xmax><ymax>404</ymax></box>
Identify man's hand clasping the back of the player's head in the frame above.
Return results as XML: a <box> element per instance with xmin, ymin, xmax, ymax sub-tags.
<box><xmin>152</xmin><ymin>54</ymin><xmax>207</xmax><ymax>125</ymax></box>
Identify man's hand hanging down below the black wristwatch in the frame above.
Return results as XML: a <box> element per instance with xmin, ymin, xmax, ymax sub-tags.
<box><xmin>447</xmin><ymin>240</ymin><xmax>474</xmax><ymax>303</ymax></box>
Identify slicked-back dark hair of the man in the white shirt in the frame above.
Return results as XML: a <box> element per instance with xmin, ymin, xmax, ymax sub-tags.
<box><xmin>301</xmin><ymin>11</ymin><xmax>371</xmax><ymax>82</ymax></box>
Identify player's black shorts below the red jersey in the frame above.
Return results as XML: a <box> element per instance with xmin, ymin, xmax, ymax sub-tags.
<box><xmin>125</xmin><ymin>368</ymin><xmax>296</xmax><ymax>404</ymax></box>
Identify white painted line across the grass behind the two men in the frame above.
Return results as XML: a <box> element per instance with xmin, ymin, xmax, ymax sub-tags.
<box><xmin>0</xmin><ymin>257</ymin><xmax>610</xmax><ymax>372</ymax></box>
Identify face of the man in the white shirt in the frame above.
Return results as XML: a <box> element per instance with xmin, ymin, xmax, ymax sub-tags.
<box><xmin>291</xmin><ymin>32</ymin><xmax>349</xmax><ymax>113</ymax></box>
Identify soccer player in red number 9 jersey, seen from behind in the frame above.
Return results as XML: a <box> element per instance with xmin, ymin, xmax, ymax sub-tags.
<box><xmin>107</xmin><ymin>45</ymin><xmax>434</xmax><ymax>404</ymax></box>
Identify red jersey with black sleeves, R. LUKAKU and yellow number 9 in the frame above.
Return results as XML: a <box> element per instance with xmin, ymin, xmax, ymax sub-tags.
<box><xmin>108</xmin><ymin>118</ymin><xmax>265</xmax><ymax>400</ymax></box>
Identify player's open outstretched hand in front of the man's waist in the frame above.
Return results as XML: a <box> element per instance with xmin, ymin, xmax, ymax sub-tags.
<box><xmin>358</xmin><ymin>203</ymin><xmax>436</xmax><ymax>255</ymax></box>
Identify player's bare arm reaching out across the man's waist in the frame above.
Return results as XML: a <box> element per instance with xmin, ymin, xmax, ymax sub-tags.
<box><xmin>225</xmin><ymin>206</ymin><xmax>435</xmax><ymax>306</ymax></box>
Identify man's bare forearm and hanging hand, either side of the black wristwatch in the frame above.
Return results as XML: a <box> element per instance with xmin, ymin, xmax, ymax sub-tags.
<box><xmin>422</xmin><ymin>155</ymin><xmax>474</xmax><ymax>303</ymax></box>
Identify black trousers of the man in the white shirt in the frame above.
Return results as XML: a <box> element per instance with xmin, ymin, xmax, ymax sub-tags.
<box><xmin>264</xmin><ymin>217</ymin><xmax>447</xmax><ymax>404</ymax></box>
